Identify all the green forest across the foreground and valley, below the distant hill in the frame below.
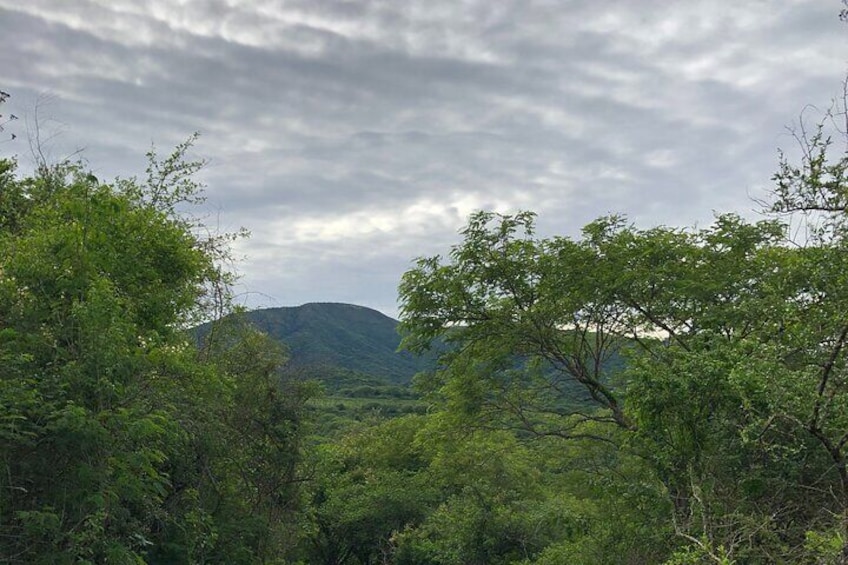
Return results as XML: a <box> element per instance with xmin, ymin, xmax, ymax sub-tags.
<box><xmin>0</xmin><ymin>78</ymin><xmax>848</xmax><ymax>565</ymax></box>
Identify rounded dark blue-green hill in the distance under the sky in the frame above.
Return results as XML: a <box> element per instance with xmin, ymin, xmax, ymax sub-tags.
<box><xmin>229</xmin><ymin>303</ymin><xmax>434</xmax><ymax>384</ymax></box>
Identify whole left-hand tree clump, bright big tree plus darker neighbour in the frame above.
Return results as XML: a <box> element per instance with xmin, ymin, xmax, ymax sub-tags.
<box><xmin>0</xmin><ymin>140</ymin><xmax>302</xmax><ymax>563</ymax></box>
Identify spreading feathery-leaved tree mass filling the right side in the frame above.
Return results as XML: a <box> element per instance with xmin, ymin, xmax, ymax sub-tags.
<box><xmin>400</xmin><ymin>93</ymin><xmax>848</xmax><ymax>562</ymax></box>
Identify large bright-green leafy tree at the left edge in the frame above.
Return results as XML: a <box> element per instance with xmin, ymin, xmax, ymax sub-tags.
<box><xmin>0</xmin><ymin>154</ymin><xmax>213</xmax><ymax>562</ymax></box>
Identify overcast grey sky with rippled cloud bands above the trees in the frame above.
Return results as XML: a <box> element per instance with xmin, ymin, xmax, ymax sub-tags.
<box><xmin>0</xmin><ymin>0</ymin><xmax>848</xmax><ymax>317</ymax></box>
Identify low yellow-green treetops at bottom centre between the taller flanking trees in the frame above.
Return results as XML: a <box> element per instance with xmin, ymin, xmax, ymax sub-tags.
<box><xmin>299</xmin><ymin>412</ymin><xmax>640</xmax><ymax>565</ymax></box>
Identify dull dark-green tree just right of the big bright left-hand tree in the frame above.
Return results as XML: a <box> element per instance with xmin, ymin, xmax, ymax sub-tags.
<box><xmin>189</xmin><ymin>315</ymin><xmax>316</xmax><ymax>563</ymax></box>
